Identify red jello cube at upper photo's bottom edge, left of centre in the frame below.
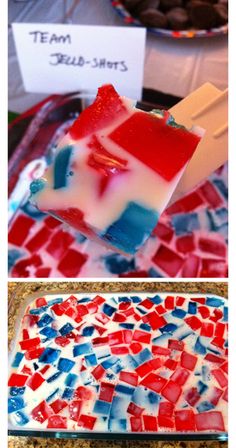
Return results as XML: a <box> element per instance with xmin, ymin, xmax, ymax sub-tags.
<box><xmin>57</xmin><ymin>249</ymin><xmax>88</xmax><ymax>277</ymax></box>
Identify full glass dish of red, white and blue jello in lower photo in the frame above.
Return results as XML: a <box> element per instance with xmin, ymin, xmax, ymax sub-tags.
<box><xmin>8</xmin><ymin>292</ymin><xmax>228</xmax><ymax>440</ymax></box>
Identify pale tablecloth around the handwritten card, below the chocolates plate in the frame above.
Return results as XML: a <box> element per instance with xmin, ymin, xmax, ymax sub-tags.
<box><xmin>9</xmin><ymin>0</ymin><xmax>228</xmax><ymax>112</ymax></box>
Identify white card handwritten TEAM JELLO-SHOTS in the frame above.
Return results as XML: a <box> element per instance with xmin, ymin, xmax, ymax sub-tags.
<box><xmin>12</xmin><ymin>23</ymin><xmax>146</xmax><ymax>99</ymax></box>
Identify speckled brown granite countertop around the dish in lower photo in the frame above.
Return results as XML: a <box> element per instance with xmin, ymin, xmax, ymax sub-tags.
<box><xmin>8</xmin><ymin>282</ymin><xmax>228</xmax><ymax>448</ymax></box>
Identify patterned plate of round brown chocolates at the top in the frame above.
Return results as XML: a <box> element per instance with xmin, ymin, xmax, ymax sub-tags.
<box><xmin>111</xmin><ymin>0</ymin><xmax>228</xmax><ymax>38</ymax></box>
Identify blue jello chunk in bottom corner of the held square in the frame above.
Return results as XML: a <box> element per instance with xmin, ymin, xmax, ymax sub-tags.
<box><xmin>101</xmin><ymin>202</ymin><xmax>159</xmax><ymax>254</ymax></box>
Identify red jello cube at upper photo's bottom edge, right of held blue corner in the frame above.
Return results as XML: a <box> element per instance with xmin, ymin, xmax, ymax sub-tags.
<box><xmin>152</xmin><ymin>244</ymin><xmax>184</xmax><ymax>277</ymax></box>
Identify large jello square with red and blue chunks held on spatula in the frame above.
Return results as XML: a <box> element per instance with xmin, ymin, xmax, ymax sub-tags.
<box><xmin>31</xmin><ymin>85</ymin><xmax>202</xmax><ymax>254</ymax></box>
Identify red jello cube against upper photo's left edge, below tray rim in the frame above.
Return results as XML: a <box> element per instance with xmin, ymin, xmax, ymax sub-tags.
<box><xmin>8</xmin><ymin>215</ymin><xmax>34</xmax><ymax>247</ymax></box>
